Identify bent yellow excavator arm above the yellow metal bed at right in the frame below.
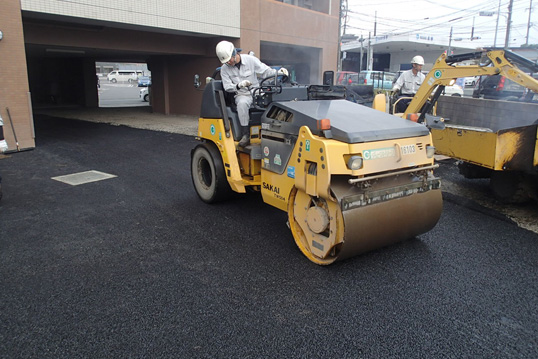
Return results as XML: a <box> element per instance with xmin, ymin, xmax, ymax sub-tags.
<box><xmin>402</xmin><ymin>49</ymin><xmax>538</xmax><ymax>122</ymax></box>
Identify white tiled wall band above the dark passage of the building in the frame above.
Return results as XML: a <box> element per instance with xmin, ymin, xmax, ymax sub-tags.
<box><xmin>21</xmin><ymin>0</ymin><xmax>241</xmax><ymax>37</ymax></box>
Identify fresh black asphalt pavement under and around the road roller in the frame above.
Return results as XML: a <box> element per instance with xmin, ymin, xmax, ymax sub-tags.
<box><xmin>0</xmin><ymin>115</ymin><xmax>538</xmax><ymax>358</ymax></box>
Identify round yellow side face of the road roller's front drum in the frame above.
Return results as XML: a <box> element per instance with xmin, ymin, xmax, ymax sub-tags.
<box><xmin>288</xmin><ymin>188</ymin><xmax>344</xmax><ymax>265</ymax></box>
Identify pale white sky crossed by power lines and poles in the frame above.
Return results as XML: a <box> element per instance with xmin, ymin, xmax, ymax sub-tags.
<box><xmin>342</xmin><ymin>0</ymin><xmax>538</xmax><ymax>47</ymax></box>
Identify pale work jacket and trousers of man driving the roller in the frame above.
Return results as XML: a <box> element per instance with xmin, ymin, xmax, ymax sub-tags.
<box><xmin>220</xmin><ymin>55</ymin><xmax>277</xmax><ymax>126</ymax></box>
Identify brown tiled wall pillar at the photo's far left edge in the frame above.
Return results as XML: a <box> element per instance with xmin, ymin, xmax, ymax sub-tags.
<box><xmin>0</xmin><ymin>0</ymin><xmax>35</xmax><ymax>151</ymax></box>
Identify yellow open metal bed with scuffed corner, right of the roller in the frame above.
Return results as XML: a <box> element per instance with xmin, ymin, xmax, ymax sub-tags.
<box><xmin>432</xmin><ymin>97</ymin><xmax>538</xmax><ymax>171</ymax></box>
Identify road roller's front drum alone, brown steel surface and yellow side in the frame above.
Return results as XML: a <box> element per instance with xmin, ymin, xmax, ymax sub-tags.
<box><xmin>288</xmin><ymin>186</ymin><xmax>443</xmax><ymax>265</ymax></box>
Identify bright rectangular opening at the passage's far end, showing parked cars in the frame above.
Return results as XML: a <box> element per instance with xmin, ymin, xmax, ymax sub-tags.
<box><xmin>95</xmin><ymin>62</ymin><xmax>151</xmax><ymax>107</ymax></box>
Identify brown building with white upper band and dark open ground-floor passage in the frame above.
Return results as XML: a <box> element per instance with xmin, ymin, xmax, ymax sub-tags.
<box><xmin>0</xmin><ymin>0</ymin><xmax>340</xmax><ymax>150</ymax></box>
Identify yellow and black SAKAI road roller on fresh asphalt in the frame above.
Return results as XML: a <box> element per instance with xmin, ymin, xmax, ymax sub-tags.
<box><xmin>191</xmin><ymin>78</ymin><xmax>442</xmax><ymax>265</ymax></box>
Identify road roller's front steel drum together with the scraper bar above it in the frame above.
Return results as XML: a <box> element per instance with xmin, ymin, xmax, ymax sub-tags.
<box><xmin>288</xmin><ymin>171</ymin><xmax>443</xmax><ymax>265</ymax></box>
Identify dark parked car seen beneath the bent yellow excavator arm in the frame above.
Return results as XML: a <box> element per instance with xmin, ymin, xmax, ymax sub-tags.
<box><xmin>473</xmin><ymin>75</ymin><xmax>534</xmax><ymax>101</ymax></box>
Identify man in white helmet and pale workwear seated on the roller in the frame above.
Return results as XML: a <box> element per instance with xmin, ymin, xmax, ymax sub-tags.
<box><xmin>216</xmin><ymin>41</ymin><xmax>288</xmax><ymax>147</ymax></box>
